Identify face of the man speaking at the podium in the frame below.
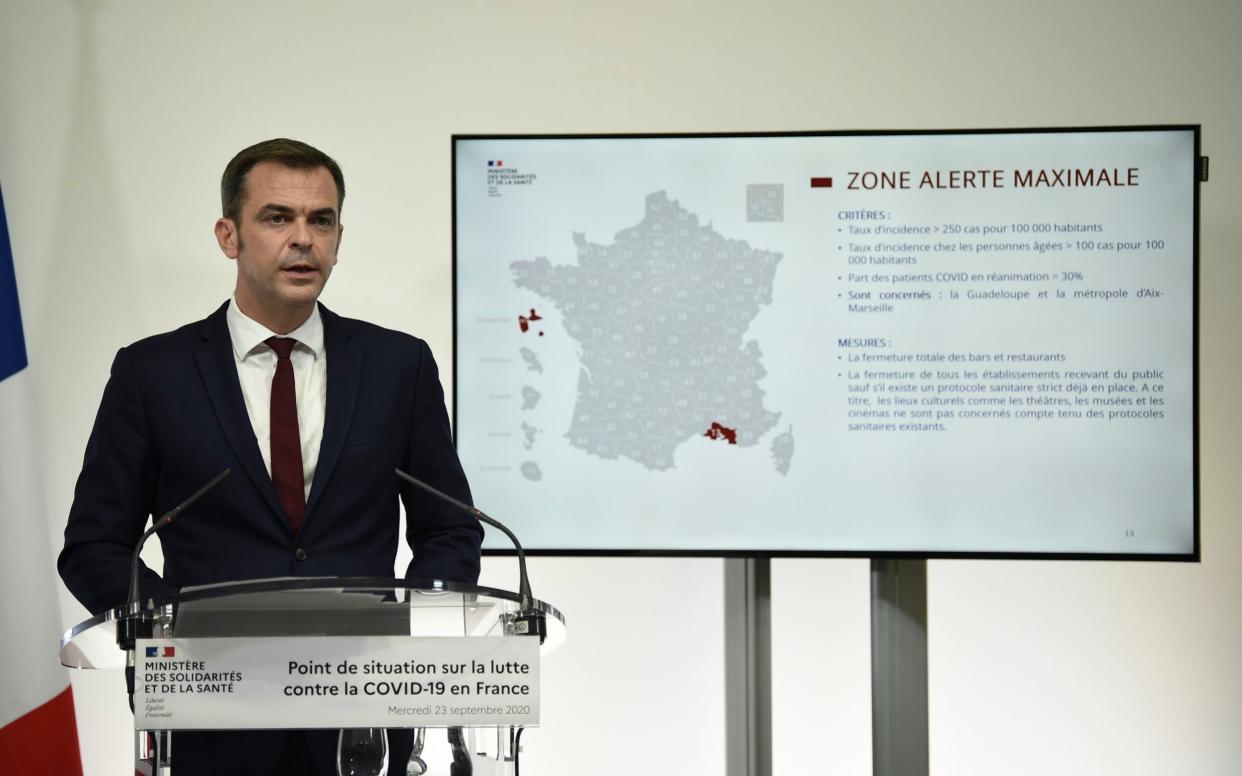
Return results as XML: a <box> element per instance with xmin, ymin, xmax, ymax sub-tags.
<box><xmin>216</xmin><ymin>161</ymin><xmax>343</xmax><ymax>334</ymax></box>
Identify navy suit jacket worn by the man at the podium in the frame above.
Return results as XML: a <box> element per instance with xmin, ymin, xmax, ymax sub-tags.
<box><xmin>58</xmin><ymin>303</ymin><xmax>483</xmax><ymax>613</ymax></box>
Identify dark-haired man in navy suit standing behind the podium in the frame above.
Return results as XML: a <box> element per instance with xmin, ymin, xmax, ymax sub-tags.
<box><xmin>58</xmin><ymin>139</ymin><xmax>482</xmax><ymax>776</ymax></box>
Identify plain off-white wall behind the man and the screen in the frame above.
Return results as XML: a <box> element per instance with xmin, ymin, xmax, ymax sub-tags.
<box><xmin>0</xmin><ymin>0</ymin><xmax>1242</xmax><ymax>776</ymax></box>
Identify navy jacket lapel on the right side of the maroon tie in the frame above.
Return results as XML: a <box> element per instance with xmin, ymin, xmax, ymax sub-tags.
<box><xmin>306</xmin><ymin>304</ymin><xmax>364</xmax><ymax>520</ymax></box>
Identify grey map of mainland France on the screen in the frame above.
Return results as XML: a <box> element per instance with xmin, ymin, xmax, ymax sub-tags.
<box><xmin>510</xmin><ymin>191</ymin><xmax>787</xmax><ymax>473</ymax></box>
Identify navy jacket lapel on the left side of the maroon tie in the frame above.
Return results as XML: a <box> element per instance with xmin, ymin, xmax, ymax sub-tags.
<box><xmin>194</xmin><ymin>302</ymin><xmax>288</xmax><ymax>526</ymax></box>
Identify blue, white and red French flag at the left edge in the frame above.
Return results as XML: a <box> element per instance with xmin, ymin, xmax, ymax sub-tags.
<box><xmin>0</xmin><ymin>182</ymin><xmax>82</xmax><ymax>776</ymax></box>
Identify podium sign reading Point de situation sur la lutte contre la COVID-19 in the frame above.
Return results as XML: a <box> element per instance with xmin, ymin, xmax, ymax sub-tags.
<box><xmin>134</xmin><ymin>636</ymin><xmax>539</xmax><ymax>730</ymax></box>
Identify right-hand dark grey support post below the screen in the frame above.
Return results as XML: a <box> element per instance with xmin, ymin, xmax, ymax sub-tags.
<box><xmin>871</xmin><ymin>557</ymin><xmax>928</xmax><ymax>776</ymax></box>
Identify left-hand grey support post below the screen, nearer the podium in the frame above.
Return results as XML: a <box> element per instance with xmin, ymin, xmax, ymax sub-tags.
<box><xmin>724</xmin><ymin>557</ymin><xmax>773</xmax><ymax>776</ymax></box>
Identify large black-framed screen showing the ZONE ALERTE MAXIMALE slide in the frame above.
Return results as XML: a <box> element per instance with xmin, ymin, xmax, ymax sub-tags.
<box><xmin>453</xmin><ymin>127</ymin><xmax>1199</xmax><ymax>557</ymax></box>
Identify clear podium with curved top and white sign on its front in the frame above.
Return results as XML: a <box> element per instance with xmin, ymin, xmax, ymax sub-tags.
<box><xmin>60</xmin><ymin>577</ymin><xmax>566</xmax><ymax>776</ymax></box>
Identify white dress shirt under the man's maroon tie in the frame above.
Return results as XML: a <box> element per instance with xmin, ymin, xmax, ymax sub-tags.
<box><xmin>225</xmin><ymin>298</ymin><xmax>328</xmax><ymax>500</ymax></box>
